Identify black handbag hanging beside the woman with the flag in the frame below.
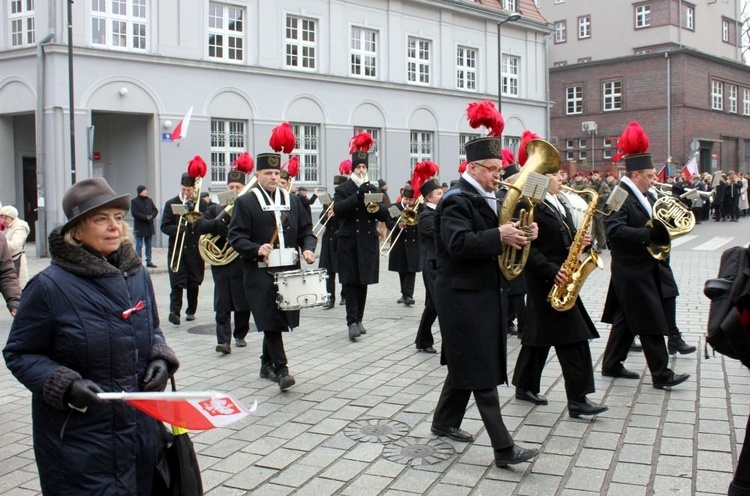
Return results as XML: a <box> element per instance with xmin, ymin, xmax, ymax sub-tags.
<box><xmin>151</xmin><ymin>376</ymin><xmax>203</xmax><ymax>496</ymax></box>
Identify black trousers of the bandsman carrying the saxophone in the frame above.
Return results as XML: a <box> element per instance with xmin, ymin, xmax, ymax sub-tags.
<box><xmin>513</xmin><ymin>341</ymin><xmax>596</xmax><ymax>401</ymax></box>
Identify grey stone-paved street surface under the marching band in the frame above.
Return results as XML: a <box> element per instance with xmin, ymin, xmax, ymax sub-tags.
<box><xmin>0</xmin><ymin>221</ymin><xmax>750</xmax><ymax>496</ymax></box>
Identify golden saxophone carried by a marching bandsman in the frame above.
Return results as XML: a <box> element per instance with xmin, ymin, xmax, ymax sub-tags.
<box><xmin>547</xmin><ymin>186</ymin><xmax>604</xmax><ymax>312</ymax></box>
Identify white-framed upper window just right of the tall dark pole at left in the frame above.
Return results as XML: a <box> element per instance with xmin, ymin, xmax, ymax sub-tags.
<box><xmin>91</xmin><ymin>0</ymin><xmax>148</xmax><ymax>51</ymax></box>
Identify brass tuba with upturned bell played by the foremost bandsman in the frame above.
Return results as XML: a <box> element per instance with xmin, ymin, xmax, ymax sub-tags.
<box><xmin>498</xmin><ymin>139</ymin><xmax>561</xmax><ymax>281</ymax></box>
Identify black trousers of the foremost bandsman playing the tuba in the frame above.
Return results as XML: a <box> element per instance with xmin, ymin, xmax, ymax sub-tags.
<box><xmin>432</xmin><ymin>370</ymin><xmax>513</xmax><ymax>450</ymax></box>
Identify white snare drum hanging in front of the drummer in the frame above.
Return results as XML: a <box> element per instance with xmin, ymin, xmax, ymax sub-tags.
<box><xmin>274</xmin><ymin>269</ymin><xmax>331</xmax><ymax>312</ymax></box>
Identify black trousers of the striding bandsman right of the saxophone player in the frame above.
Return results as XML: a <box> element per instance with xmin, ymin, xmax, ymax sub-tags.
<box><xmin>602</xmin><ymin>308</ymin><xmax>674</xmax><ymax>382</ymax></box>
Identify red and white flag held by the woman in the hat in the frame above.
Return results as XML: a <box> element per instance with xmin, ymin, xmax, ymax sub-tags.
<box><xmin>98</xmin><ymin>391</ymin><xmax>258</xmax><ymax>431</ymax></box>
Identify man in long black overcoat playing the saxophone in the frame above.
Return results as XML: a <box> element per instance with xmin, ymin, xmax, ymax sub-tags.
<box><xmin>513</xmin><ymin>173</ymin><xmax>607</xmax><ymax>417</ymax></box>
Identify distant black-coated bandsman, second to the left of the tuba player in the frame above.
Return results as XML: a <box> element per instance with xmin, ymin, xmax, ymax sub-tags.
<box><xmin>386</xmin><ymin>185</ymin><xmax>422</xmax><ymax>307</ymax></box>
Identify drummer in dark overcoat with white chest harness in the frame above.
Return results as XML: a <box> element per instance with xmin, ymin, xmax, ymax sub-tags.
<box><xmin>229</xmin><ymin>153</ymin><xmax>318</xmax><ymax>391</ymax></box>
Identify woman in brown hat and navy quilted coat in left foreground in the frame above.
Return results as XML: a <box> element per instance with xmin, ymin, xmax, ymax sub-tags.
<box><xmin>3</xmin><ymin>178</ymin><xmax>179</xmax><ymax>495</ymax></box>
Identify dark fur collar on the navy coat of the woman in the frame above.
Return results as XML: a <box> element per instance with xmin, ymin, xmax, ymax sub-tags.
<box><xmin>49</xmin><ymin>227</ymin><xmax>143</xmax><ymax>278</ymax></box>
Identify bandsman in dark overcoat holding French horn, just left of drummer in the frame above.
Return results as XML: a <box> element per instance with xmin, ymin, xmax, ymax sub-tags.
<box><xmin>196</xmin><ymin>170</ymin><xmax>250</xmax><ymax>355</ymax></box>
